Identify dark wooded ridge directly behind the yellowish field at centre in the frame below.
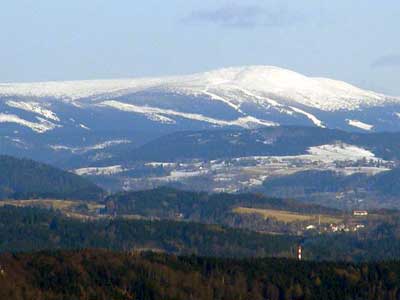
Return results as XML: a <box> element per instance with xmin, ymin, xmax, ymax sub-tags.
<box><xmin>106</xmin><ymin>187</ymin><xmax>340</xmax><ymax>217</ymax></box>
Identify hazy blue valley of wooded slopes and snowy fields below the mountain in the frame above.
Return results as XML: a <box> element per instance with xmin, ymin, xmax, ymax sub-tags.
<box><xmin>64</xmin><ymin>127</ymin><xmax>400</xmax><ymax>210</ymax></box>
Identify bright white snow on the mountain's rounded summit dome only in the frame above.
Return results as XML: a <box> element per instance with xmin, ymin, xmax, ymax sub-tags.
<box><xmin>169</xmin><ymin>66</ymin><xmax>394</xmax><ymax>111</ymax></box>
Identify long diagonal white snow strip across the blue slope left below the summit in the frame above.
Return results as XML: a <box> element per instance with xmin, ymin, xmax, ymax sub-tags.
<box><xmin>98</xmin><ymin>100</ymin><xmax>278</xmax><ymax>128</ymax></box>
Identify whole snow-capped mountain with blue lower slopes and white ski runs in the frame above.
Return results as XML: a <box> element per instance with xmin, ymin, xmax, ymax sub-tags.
<box><xmin>0</xmin><ymin>66</ymin><xmax>400</xmax><ymax>164</ymax></box>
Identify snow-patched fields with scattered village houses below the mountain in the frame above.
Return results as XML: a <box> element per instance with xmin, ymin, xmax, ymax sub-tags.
<box><xmin>75</xmin><ymin>143</ymin><xmax>392</xmax><ymax>192</ymax></box>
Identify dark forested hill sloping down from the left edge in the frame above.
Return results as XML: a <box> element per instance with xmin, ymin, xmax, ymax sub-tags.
<box><xmin>0</xmin><ymin>155</ymin><xmax>103</xmax><ymax>200</ymax></box>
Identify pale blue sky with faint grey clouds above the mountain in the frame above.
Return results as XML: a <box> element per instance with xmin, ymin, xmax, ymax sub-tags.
<box><xmin>0</xmin><ymin>0</ymin><xmax>400</xmax><ymax>95</ymax></box>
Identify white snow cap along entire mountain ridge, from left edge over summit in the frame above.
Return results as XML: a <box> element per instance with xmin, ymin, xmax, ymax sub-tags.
<box><xmin>0</xmin><ymin>66</ymin><xmax>400</xmax><ymax>111</ymax></box>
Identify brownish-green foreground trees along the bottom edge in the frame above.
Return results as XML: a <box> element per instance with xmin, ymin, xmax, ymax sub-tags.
<box><xmin>0</xmin><ymin>250</ymin><xmax>400</xmax><ymax>300</ymax></box>
